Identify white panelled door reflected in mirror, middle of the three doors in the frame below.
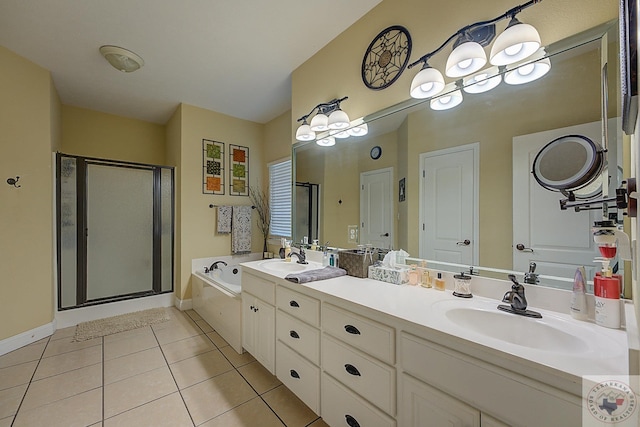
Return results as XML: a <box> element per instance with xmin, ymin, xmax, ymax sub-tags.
<box><xmin>420</xmin><ymin>143</ymin><xmax>479</xmax><ymax>265</ymax></box>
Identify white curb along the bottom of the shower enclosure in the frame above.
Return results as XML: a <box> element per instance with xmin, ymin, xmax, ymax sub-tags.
<box><xmin>56</xmin><ymin>293</ymin><xmax>174</xmax><ymax>329</ymax></box>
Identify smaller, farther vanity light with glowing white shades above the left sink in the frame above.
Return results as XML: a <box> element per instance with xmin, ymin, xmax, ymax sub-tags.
<box><xmin>296</xmin><ymin>96</ymin><xmax>369</xmax><ymax>147</ymax></box>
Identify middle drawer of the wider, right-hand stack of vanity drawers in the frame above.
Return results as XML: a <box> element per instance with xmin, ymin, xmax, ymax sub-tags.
<box><xmin>322</xmin><ymin>335</ymin><xmax>396</xmax><ymax>416</ymax></box>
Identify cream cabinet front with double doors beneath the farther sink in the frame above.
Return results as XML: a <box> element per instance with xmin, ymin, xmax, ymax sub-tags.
<box><xmin>242</xmin><ymin>272</ymin><xmax>276</xmax><ymax>374</ymax></box>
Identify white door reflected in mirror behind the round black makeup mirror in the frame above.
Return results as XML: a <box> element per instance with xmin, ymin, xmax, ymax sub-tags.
<box><xmin>513</xmin><ymin>122</ymin><xmax>604</xmax><ymax>287</ymax></box>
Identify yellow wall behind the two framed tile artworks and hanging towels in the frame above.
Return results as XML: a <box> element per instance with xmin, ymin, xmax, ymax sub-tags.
<box><xmin>169</xmin><ymin>104</ymin><xmax>265</xmax><ymax>299</ymax></box>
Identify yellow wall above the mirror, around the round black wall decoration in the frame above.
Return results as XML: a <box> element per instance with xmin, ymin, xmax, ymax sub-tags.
<box><xmin>291</xmin><ymin>0</ymin><xmax>618</xmax><ymax>130</ymax></box>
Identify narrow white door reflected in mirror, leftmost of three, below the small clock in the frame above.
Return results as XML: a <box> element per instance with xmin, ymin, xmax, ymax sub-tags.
<box><xmin>360</xmin><ymin>168</ymin><xmax>393</xmax><ymax>248</ymax></box>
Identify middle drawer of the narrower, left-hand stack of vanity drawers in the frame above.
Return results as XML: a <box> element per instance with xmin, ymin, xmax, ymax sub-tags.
<box><xmin>276</xmin><ymin>309</ymin><xmax>320</xmax><ymax>365</ymax></box>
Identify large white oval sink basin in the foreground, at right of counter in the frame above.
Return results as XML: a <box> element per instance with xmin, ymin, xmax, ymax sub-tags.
<box><xmin>445</xmin><ymin>308</ymin><xmax>589</xmax><ymax>353</ymax></box>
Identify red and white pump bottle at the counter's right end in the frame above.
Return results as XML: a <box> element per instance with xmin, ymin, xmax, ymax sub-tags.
<box><xmin>593</xmin><ymin>259</ymin><xmax>620</xmax><ymax>329</ymax></box>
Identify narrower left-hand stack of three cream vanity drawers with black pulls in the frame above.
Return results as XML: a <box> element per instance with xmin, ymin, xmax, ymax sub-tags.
<box><xmin>276</xmin><ymin>285</ymin><xmax>320</xmax><ymax>414</ymax></box>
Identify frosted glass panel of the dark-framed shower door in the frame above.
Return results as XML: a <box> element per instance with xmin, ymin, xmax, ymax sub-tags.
<box><xmin>86</xmin><ymin>163</ymin><xmax>154</xmax><ymax>301</ymax></box>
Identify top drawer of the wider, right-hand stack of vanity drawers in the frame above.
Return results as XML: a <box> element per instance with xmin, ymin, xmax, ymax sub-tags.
<box><xmin>322</xmin><ymin>304</ymin><xmax>395</xmax><ymax>364</ymax></box>
